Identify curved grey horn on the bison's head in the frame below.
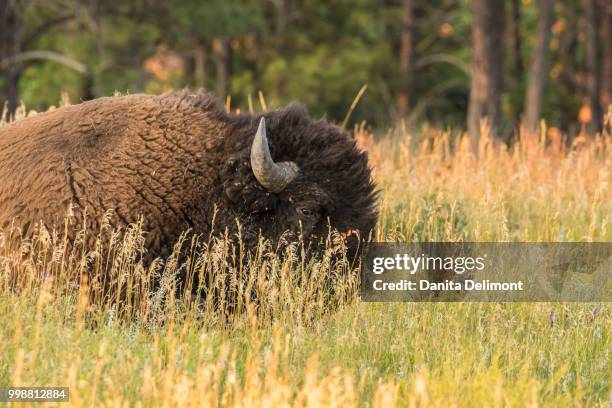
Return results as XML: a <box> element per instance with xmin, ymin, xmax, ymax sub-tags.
<box><xmin>251</xmin><ymin>118</ymin><xmax>300</xmax><ymax>193</ymax></box>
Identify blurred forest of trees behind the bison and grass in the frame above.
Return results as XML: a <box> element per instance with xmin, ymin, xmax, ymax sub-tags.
<box><xmin>0</xmin><ymin>0</ymin><xmax>612</xmax><ymax>137</ymax></box>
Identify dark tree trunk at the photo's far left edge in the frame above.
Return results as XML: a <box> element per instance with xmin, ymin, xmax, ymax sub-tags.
<box><xmin>0</xmin><ymin>0</ymin><xmax>21</xmax><ymax>119</ymax></box>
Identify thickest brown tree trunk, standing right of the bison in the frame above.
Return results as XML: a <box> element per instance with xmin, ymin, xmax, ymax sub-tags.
<box><xmin>467</xmin><ymin>0</ymin><xmax>504</xmax><ymax>150</ymax></box>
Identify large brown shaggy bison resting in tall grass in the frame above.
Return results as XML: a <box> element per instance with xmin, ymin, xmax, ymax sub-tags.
<box><xmin>0</xmin><ymin>91</ymin><xmax>377</xmax><ymax>257</ymax></box>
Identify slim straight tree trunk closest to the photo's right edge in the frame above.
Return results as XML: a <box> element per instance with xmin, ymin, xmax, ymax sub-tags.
<box><xmin>586</xmin><ymin>0</ymin><xmax>603</xmax><ymax>132</ymax></box>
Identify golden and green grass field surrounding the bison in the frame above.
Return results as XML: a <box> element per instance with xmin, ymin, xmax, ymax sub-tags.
<box><xmin>0</xmin><ymin>107</ymin><xmax>612</xmax><ymax>407</ymax></box>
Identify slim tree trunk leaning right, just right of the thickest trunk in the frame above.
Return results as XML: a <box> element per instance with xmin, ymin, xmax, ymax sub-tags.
<box><xmin>525</xmin><ymin>0</ymin><xmax>555</xmax><ymax>132</ymax></box>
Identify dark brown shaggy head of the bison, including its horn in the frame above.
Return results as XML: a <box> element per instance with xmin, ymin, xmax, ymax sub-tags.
<box><xmin>218</xmin><ymin>105</ymin><xmax>377</xmax><ymax>253</ymax></box>
